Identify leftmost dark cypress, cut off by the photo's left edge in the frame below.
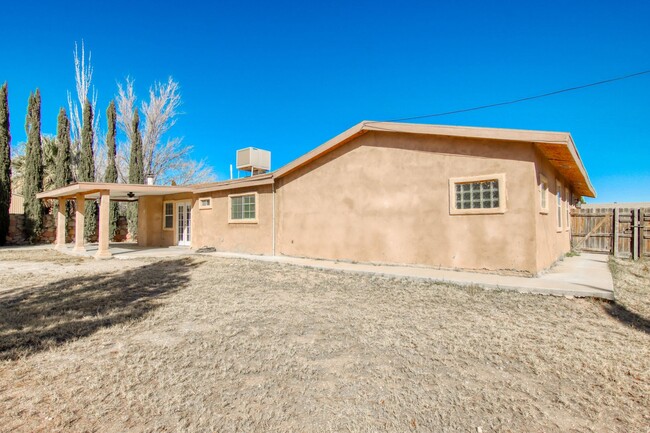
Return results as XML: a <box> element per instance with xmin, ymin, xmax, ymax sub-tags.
<box><xmin>0</xmin><ymin>83</ymin><xmax>11</xmax><ymax>245</ymax></box>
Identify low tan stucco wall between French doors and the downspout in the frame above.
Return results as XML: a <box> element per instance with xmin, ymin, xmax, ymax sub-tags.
<box><xmin>192</xmin><ymin>185</ymin><xmax>273</xmax><ymax>254</ymax></box>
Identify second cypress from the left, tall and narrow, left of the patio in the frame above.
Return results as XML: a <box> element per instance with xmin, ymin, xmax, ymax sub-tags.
<box><xmin>23</xmin><ymin>89</ymin><xmax>43</xmax><ymax>242</ymax></box>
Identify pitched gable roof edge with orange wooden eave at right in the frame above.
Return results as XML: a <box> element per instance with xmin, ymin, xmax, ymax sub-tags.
<box><xmin>273</xmin><ymin>121</ymin><xmax>596</xmax><ymax>197</ymax></box>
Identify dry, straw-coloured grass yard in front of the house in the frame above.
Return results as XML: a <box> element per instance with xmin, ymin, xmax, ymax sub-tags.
<box><xmin>0</xmin><ymin>250</ymin><xmax>650</xmax><ymax>433</ymax></box>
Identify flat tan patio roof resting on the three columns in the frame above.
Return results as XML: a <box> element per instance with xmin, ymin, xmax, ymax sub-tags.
<box><xmin>36</xmin><ymin>182</ymin><xmax>192</xmax><ymax>201</ymax></box>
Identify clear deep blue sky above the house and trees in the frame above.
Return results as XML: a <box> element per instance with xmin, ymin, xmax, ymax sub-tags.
<box><xmin>0</xmin><ymin>0</ymin><xmax>650</xmax><ymax>202</ymax></box>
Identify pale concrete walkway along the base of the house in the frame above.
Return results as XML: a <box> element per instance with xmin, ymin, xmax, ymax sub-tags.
<box><xmin>208</xmin><ymin>252</ymin><xmax>614</xmax><ymax>300</ymax></box>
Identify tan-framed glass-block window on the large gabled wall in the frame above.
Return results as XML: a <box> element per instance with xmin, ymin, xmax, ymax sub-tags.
<box><xmin>449</xmin><ymin>173</ymin><xmax>506</xmax><ymax>215</ymax></box>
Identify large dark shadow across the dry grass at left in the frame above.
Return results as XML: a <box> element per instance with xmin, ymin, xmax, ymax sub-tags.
<box><xmin>0</xmin><ymin>258</ymin><xmax>200</xmax><ymax>360</ymax></box>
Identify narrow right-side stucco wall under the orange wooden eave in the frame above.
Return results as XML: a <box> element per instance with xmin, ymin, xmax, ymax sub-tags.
<box><xmin>535</xmin><ymin>148</ymin><xmax>571</xmax><ymax>271</ymax></box>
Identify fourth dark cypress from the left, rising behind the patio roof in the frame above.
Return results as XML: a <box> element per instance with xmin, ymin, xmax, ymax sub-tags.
<box><xmin>77</xmin><ymin>99</ymin><xmax>98</xmax><ymax>240</ymax></box>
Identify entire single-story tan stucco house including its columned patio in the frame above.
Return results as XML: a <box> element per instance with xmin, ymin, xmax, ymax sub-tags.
<box><xmin>38</xmin><ymin>121</ymin><xmax>595</xmax><ymax>274</ymax></box>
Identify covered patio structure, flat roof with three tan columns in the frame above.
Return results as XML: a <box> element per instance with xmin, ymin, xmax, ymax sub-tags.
<box><xmin>36</xmin><ymin>182</ymin><xmax>192</xmax><ymax>259</ymax></box>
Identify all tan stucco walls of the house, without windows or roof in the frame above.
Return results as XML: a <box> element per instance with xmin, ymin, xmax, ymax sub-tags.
<box><xmin>138</xmin><ymin>128</ymin><xmax>570</xmax><ymax>273</ymax></box>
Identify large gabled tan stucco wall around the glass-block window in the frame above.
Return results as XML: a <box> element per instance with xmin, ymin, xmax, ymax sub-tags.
<box><xmin>276</xmin><ymin>133</ymin><xmax>539</xmax><ymax>273</ymax></box>
